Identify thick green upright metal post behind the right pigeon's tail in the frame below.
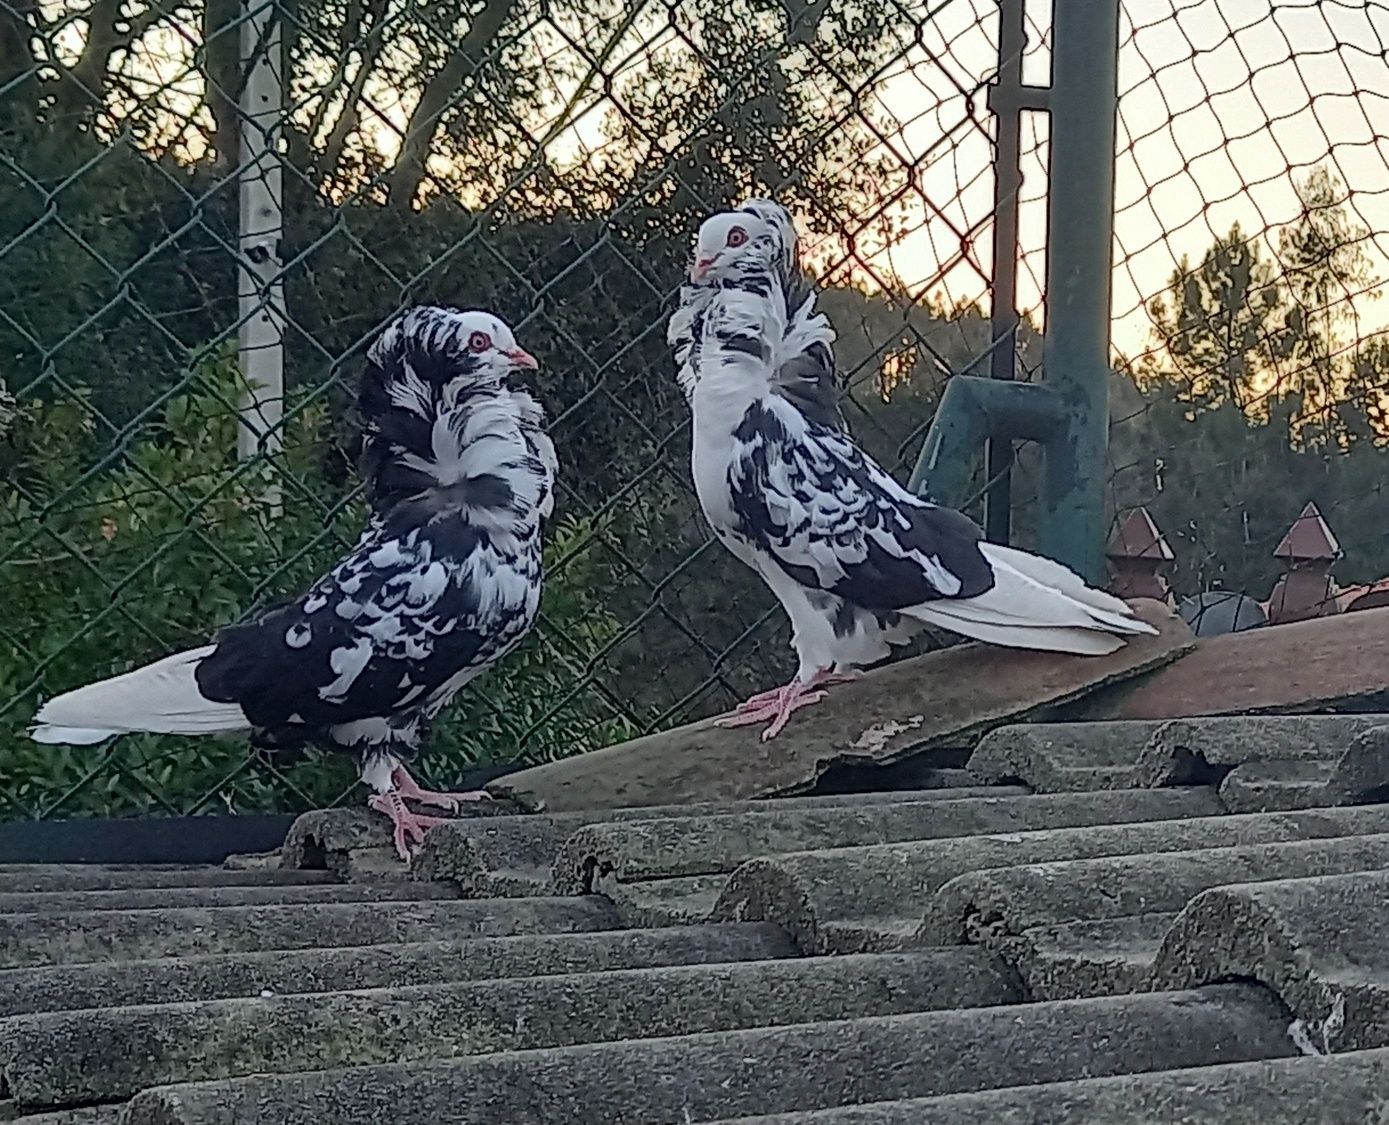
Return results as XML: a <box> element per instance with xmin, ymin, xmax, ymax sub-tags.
<box><xmin>1040</xmin><ymin>0</ymin><xmax>1120</xmax><ymax>583</ymax></box>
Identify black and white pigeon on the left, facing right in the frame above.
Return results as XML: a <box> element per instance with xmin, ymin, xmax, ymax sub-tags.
<box><xmin>32</xmin><ymin>307</ymin><xmax>557</xmax><ymax>861</ymax></box>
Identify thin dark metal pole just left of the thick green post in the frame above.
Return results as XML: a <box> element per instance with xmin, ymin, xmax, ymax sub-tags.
<box><xmin>983</xmin><ymin>0</ymin><xmax>1026</xmax><ymax>543</ymax></box>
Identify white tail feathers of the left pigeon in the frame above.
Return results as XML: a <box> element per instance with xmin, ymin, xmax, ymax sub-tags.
<box><xmin>29</xmin><ymin>644</ymin><xmax>250</xmax><ymax>746</ymax></box>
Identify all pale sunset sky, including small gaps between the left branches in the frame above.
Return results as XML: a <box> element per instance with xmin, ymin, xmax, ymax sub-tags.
<box><xmin>65</xmin><ymin>0</ymin><xmax>1389</xmax><ymax>356</ymax></box>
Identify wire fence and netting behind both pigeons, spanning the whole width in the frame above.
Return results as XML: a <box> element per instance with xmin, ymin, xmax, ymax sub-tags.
<box><xmin>0</xmin><ymin>0</ymin><xmax>1389</xmax><ymax>818</ymax></box>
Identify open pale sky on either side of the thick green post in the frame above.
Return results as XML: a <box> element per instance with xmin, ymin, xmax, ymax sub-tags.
<box><xmin>822</xmin><ymin>0</ymin><xmax>1389</xmax><ymax>356</ymax></box>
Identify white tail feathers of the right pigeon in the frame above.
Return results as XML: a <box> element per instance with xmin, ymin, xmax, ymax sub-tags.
<box><xmin>903</xmin><ymin>543</ymin><xmax>1157</xmax><ymax>656</ymax></box>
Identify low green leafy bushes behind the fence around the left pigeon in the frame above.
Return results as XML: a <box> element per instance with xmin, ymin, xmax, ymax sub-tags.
<box><xmin>0</xmin><ymin>354</ymin><xmax>635</xmax><ymax>815</ymax></box>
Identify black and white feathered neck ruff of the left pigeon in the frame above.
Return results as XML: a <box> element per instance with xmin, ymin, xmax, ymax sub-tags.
<box><xmin>357</xmin><ymin>307</ymin><xmax>553</xmax><ymax>511</ymax></box>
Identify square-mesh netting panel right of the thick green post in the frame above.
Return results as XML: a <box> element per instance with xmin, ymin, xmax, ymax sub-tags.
<box><xmin>1110</xmin><ymin>0</ymin><xmax>1389</xmax><ymax>628</ymax></box>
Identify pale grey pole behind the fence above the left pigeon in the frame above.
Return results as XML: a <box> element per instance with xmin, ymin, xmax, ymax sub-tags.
<box><xmin>236</xmin><ymin>0</ymin><xmax>285</xmax><ymax>457</ymax></box>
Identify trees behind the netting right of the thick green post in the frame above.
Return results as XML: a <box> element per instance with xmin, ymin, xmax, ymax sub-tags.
<box><xmin>1110</xmin><ymin>169</ymin><xmax>1389</xmax><ymax>597</ymax></box>
